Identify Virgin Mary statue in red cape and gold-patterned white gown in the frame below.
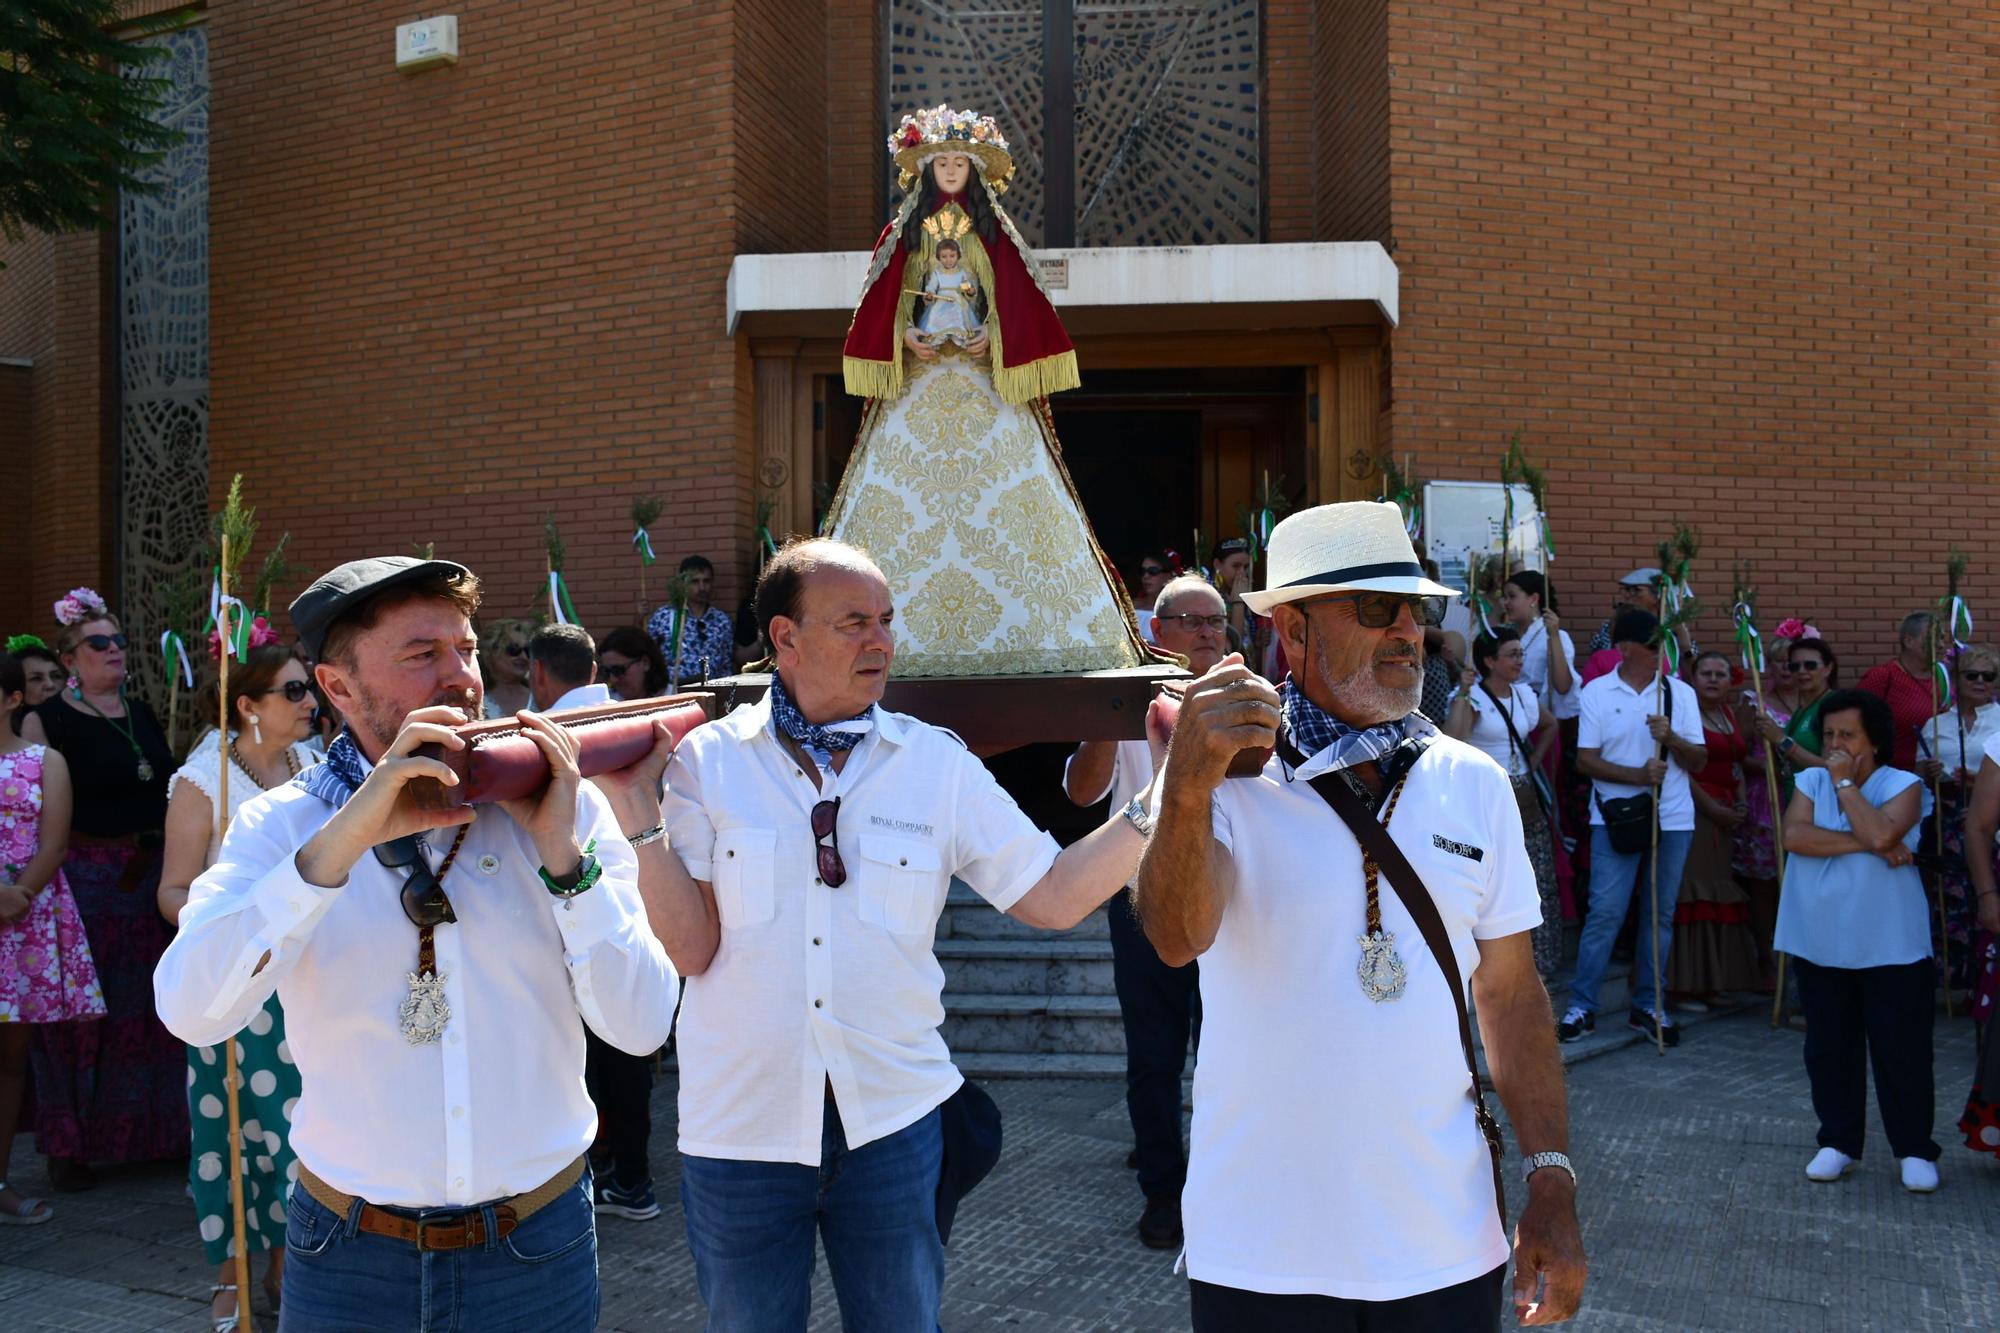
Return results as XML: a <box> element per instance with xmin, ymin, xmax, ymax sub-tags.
<box><xmin>826</xmin><ymin>106</ymin><xmax>1146</xmax><ymax>677</ymax></box>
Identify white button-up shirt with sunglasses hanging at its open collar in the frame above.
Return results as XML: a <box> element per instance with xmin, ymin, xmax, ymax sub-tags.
<box><xmin>662</xmin><ymin>697</ymin><xmax>1058</xmax><ymax>1167</ymax></box>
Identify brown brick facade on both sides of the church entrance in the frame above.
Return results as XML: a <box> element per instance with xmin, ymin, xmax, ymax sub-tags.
<box><xmin>0</xmin><ymin>0</ymin><xmax>2000</xmax><ymax>660</ymax></box>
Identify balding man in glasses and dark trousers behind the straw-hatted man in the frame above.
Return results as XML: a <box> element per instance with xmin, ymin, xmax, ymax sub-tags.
<box><xmin>1062</xmin><ymin>574</ymin><xmax>1230</xmax><ymax>1249</ymax></box>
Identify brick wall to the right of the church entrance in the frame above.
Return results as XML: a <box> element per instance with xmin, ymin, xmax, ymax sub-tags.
<box><xmin>1388</xmin><ymin>0</ymin><xmax>2000</xmax><ymax>664</ymax></box>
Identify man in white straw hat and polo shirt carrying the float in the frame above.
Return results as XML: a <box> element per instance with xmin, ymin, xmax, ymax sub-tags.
<box><xmin>1138</xmin><ymin>502</ymin><xmax>1584</xmax><ymax>1331</ymax></box>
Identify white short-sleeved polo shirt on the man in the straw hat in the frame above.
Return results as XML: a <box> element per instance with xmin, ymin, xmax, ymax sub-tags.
<box><xmin>1182</xmin><ymin>737</ymin><xmax>1542</xmax><ymax>1301</ymax></box>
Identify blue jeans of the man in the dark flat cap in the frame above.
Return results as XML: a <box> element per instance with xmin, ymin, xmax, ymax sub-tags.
<box><xmin>278</xmin><ymin>1171</ymin><xmax>598</xmax><ymax>1333</ymax></box>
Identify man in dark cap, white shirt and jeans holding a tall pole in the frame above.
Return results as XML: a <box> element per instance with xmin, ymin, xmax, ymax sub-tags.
<box><xmin>1556</xmin><ymin>608</ymin><xmax>1708</xmax><ymax>1047</ymax></box>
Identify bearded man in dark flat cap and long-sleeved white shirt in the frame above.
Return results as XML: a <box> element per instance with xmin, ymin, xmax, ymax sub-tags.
<box><xmin>154</xmin><ymin>556</ymin><xmax>676</xmax><ymax>1331</ymax></box>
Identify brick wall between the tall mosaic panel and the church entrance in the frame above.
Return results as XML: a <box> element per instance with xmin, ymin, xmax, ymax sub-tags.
<box><xmin>210</xmin><ymin>0</ymin><xmax>760</xmax><ymax>626</ymax></box>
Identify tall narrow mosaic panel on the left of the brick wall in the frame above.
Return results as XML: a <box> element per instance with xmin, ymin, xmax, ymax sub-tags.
<box><xmin>114</xmin><ymin>28</ymin><xmax>208</xmax><ymax>707</ymax></box>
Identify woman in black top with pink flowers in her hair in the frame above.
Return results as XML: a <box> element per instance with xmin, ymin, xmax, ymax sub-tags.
<box><xmin>32</xmin><ymin>588</ymin><xmax>188</xmax><ymax>1191</ymax></box>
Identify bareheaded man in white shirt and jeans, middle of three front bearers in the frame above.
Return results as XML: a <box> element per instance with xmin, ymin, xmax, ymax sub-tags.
<box><xmin>656</xmin><ymin>540</ymin><xmax>1144</xmax><ymax>1329</ymax></box>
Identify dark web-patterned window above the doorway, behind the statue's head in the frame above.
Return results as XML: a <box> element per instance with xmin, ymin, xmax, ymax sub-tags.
<box><xmin>884</xmin><ymin>0</ymin><xmax>1262</xmax><ymax>246</ymax></box>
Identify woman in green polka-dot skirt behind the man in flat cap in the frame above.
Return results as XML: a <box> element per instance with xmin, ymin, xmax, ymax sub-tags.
<box><xmin>158</xmin><ymin>630</ymin><xmax>316</xmax><ymax>1333</ymax></box>
